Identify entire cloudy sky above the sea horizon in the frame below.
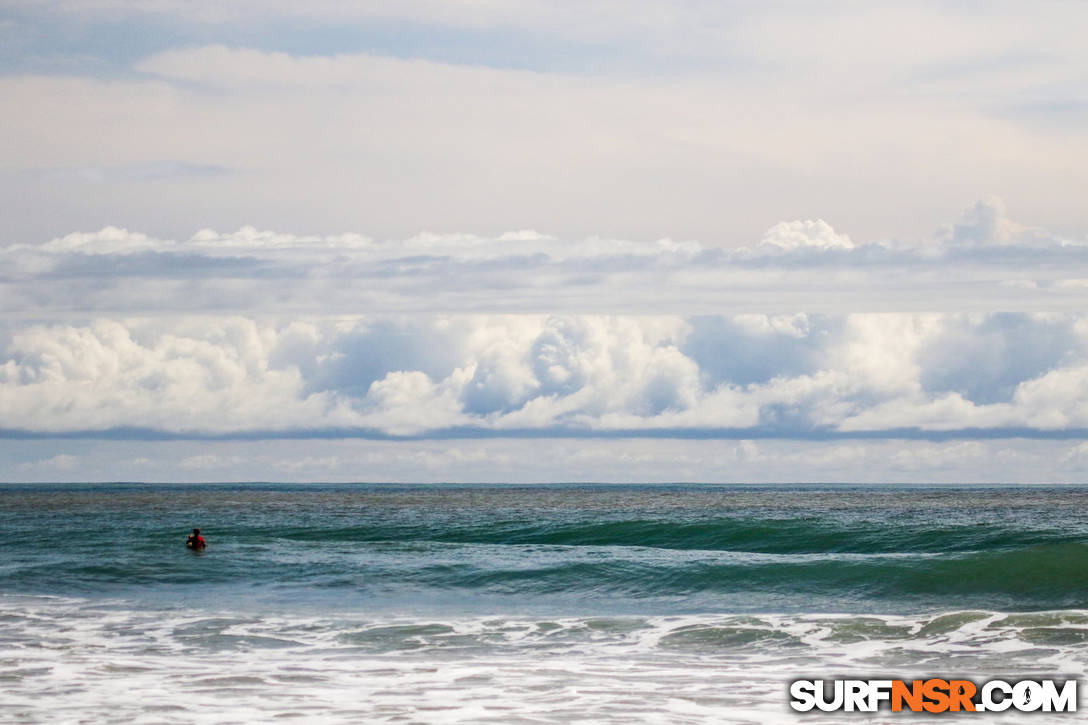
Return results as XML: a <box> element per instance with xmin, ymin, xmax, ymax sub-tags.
<box><xmin>0</xmin><ymin>5</ymin><xmax>1088</xmax><ymax>482</ymax></box>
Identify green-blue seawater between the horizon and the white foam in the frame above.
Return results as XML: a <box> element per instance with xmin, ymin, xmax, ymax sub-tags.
<box><xmin>0</xmin><ymin>483</ymin><xmax>1088</xmax><ymax>615</ymax></box>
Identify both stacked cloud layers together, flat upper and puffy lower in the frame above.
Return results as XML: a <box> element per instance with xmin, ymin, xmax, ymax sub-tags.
<box><xmin>6</xmin><ymin>199</ymin><xmax>1088</xmax><ymax>439</ymax></box>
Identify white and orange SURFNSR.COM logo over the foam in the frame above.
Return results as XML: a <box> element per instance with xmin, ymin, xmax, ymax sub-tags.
<box><xmin>790</xmin><ymin>677</ymin><xmax>1077</xmax><ymax>713</ymax></box>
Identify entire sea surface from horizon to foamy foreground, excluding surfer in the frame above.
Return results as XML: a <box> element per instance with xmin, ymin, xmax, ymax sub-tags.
<box><xmin>0</xmin><ymin>483</ymin><xmax>1088</xmax><ymax>723</ymax></box>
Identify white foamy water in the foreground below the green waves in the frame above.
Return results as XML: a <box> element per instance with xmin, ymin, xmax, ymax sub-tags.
<box><xmin>0</xmin><ymin>597</ymin><xmax>1088</xmax><ymax>724</ymax></box>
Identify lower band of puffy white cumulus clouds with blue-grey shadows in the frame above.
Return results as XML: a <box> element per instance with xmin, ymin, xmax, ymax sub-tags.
<box><xmin>6</xmin><ymin>314</ymin><xmax>1088</xmax><ymax>438</ymax></box>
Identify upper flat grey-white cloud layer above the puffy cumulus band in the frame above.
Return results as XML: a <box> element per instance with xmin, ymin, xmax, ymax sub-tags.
<box><xmin>6</xmin><ymin>199</ymin><xmax>1088</xmax><ymax>320</ymax></box>
